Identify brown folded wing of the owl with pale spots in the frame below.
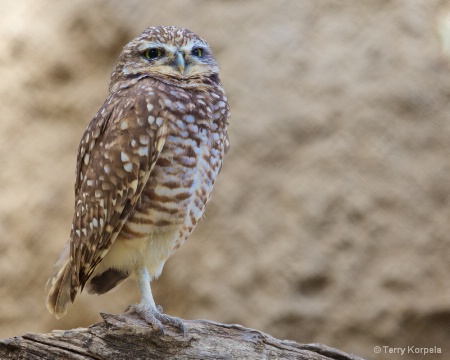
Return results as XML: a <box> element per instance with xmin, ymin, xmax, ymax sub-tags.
<box><xmin>70</xmin><ymin>88</ymin><xmax>166</xmax><ymax>292</ymax></box>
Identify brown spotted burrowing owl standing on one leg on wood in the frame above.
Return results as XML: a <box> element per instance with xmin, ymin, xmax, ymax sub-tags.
<box><xmin>47</xmin><ymin>26</ymin><xmax>229</xmax><ymax>332</ymax></box>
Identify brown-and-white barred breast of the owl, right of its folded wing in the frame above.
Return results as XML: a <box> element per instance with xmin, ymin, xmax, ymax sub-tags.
<box><xmin>122</xmin><ymin>114</ymin><xmax>223</xmax><ymax>238</ymax></box>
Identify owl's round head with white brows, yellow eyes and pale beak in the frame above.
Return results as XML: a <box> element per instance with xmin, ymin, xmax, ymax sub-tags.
<box><xmin>111</xmin><ymin>26</ymin><xmax>219</xmax><ymax>87</ymax></box>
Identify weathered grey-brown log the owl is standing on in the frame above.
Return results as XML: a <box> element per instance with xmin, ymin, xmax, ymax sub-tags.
<box><xmin>0</xmin><ymin>314</ymin><xmax>362</xmax><ymax>360</ymax></box>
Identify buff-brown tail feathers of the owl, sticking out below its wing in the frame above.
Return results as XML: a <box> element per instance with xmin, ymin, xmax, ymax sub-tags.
<box><xmin>46</xmin><ymin>244</ymin><xmax>78</xmax><ymax>319</ymax></box>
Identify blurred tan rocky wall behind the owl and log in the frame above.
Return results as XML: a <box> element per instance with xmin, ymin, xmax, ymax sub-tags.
<box><xmin>0</xmin><ymin>0</ymin><xmax>450</xmax><ymax>359</ymax></box>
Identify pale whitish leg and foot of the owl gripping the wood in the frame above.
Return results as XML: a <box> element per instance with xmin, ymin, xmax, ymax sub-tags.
<box><xmin>128</xmin><ymin>267</ymin><xmax>186</xmax><ymax>335</ymax></box>
